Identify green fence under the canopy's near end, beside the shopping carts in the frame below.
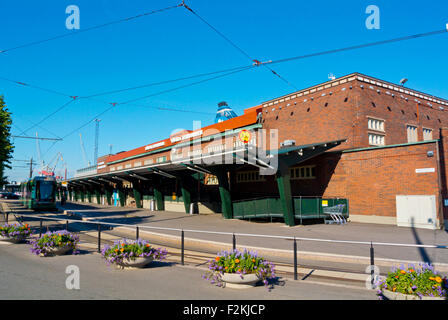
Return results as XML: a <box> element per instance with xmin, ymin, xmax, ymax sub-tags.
<box><xmin>232</xmin><ymin>197</ymin><xmax>349</xmax><ymax>220</ymax></box>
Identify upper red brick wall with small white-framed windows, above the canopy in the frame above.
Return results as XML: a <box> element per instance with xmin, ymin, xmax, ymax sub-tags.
<box><xmin>262</xmin><ymin>80</ymin><xmax>448</xmax><ymax>150</ymax></box>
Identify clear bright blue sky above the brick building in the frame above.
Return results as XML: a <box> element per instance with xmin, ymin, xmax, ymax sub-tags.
<box><xmin>0</xmin><ymin>0</ymin><xmax>448</xmax><ymax>182</ymax></box>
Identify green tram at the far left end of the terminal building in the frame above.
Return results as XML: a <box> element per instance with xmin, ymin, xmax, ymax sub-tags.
<box><xmin>21</xmin><ymin>176</ymin><xmax>57</xmax><ymax>211</ymax></box>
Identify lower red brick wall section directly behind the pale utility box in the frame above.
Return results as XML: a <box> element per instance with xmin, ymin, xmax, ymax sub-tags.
<box><xmin>323</xmin><ymin>142</ymin><xmax>440</xmax><ymax>217</ymax></box>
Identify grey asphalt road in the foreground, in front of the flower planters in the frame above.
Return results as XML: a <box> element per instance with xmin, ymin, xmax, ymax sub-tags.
<box><xmin>0</xmin><ymin>243</ymin><xmax>378</xmax><ymax>300</ymax></box>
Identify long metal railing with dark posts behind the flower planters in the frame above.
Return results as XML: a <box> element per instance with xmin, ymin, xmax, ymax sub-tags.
<box><xmin>3</xmin><ymin>211</ymin><xmax>448</xmax><ymax>285</ymax></box>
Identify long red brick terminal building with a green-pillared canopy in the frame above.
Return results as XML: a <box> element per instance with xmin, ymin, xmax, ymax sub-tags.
<box><xmin>67</xmin><ymin>73</ymin><xmax>448</xmax><ymax>229</ymax></box>
